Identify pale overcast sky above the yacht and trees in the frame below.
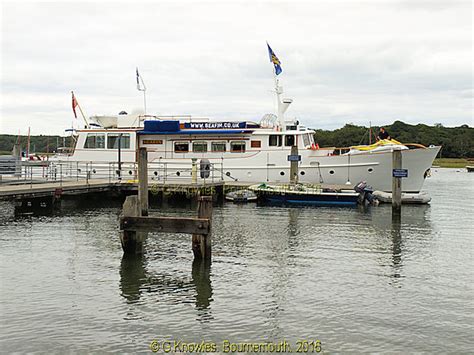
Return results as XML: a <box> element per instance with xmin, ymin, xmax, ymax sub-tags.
<box><xmin>0</xmin><ymin>0</ymin><xmax>473</xmax><ymax>134</ymax></box>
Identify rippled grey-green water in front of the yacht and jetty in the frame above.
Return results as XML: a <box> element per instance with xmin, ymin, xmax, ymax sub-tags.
<box><xmin>0</xmin><ymin>169</ymin><xmax>474</xmax><ymax>353</ymax></box>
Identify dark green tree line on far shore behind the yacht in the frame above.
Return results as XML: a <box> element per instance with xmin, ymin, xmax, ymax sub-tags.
<box><xmin>0</xmin><ymin>121</ymin><xmax>474</xmax><ymax>158</ymax></box>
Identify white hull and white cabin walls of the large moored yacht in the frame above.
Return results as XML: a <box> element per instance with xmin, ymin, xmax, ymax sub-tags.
<box><xmin>63</xmin><ymin>130</ymin><xmax>441</xmax><ymax>193</ymax></box>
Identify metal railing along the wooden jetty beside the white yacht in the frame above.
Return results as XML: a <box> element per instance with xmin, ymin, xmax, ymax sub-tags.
<box><xmin>0</xmin><ymin>158</ymin><xmax>228</xmax><ymax>186</ymax></box>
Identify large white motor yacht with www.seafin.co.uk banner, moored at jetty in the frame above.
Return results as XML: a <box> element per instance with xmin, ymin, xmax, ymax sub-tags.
<box><xmin>58</xmin><ymin>67</ymin><xmax>441</xmax><ymax>193</ymax></box>
